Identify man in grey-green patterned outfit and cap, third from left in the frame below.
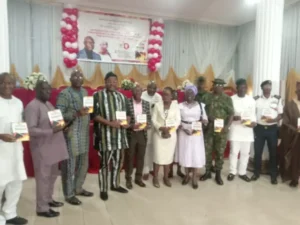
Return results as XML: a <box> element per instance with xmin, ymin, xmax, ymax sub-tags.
<box><xmin>56</xmin><ymin>70</ymin><xmax>93</xmax><ymax>205</ymax></box>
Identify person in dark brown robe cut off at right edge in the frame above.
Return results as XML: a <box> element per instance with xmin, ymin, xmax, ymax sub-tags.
<box><xmin>279</xmin><ymin>81</ymin><xmax>300</xmax><ymax>188</ymax></box>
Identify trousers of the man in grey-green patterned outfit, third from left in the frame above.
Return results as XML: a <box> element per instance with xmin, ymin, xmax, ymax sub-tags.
<box><xmin>61</xmin><ymin>151</ymin><xmax>89</xmax><ymax>199</ymax></box>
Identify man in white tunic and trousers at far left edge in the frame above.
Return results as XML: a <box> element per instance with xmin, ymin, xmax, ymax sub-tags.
<box><xmin>0</xmin><ymin>73</ymin><xmax>27</xmax><ymax>225</ymax></box>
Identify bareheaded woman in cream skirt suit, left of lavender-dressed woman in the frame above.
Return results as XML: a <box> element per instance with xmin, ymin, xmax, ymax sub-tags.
<box><xmin>152</xmin><ymin>87</ymin><xmax>180</xmax><ymax>188</ymax></box>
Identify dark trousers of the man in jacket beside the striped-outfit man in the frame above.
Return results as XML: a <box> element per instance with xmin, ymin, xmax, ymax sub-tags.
<box><xmin>125</xmin><ymin>131</ymin><xmax>147</xmax><ymax>181</ymax></box>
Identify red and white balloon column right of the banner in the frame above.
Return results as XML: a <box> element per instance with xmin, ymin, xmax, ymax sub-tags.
<box><xmin>148</xmin><ymin>19</ymin><xmax>165</xmax><ymax>72</ymax></box>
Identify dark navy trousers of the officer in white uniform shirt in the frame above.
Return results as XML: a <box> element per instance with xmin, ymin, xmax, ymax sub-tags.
<box><xmin>254</xmin><ymin>124</ymin><xmax>278</xmax><ymax>177</ymax></box>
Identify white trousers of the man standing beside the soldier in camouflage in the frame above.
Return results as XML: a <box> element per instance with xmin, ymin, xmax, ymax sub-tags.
<box><xmin>229</xmin><ymin>141</ymin><xmax>251</xmax><ymax>176</ymax></box>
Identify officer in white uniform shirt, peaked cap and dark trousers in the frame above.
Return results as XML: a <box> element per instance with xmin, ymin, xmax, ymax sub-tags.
<box><xmin>251</xmin><ymin>80</ymin><xmax>283</xmax><ymax>185</ymax></box>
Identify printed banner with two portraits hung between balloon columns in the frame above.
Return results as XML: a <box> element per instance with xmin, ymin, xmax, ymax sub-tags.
<box><xmin>77</xmin><ymin>11</ymin><xmax>151</xmax><ymax>64</ymax></box>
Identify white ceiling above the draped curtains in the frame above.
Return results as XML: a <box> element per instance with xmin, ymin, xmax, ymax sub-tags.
<box><xmin>31</xmin><ymin>0</ymin><xmax>298</xmax><ymax>26</ymax></box>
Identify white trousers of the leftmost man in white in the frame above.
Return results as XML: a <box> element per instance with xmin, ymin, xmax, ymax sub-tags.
<box><xmin>0</xmin><ymin>181</ymin><xmax>23</xmax><ymax>225</ymax></box>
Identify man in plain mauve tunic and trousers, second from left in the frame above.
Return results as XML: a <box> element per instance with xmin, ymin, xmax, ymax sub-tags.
<box><xmin>24</xmin><ymin>80</ymin><xmax>69</xmax><ymax>218</ymax></box>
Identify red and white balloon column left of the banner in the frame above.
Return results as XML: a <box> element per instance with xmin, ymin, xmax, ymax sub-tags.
<box><xmin>60</xmin><ymin>5</ymin><xmax>79</xmax><ymax>68</ymax></box>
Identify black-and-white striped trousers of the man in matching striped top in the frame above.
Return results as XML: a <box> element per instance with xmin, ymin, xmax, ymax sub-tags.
<box><xmin>98</xmin><ymin>149</ymin><xmax>122</xmax><ymax>192</ymax></box>
